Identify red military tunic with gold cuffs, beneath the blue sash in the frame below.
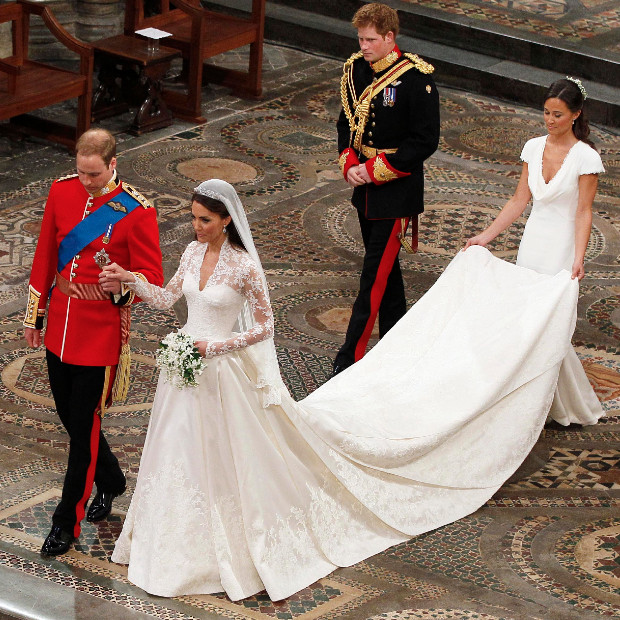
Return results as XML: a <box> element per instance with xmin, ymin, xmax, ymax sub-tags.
<box><xmin>24</xmin><ymin>172</ymin><xmax>163</xmax><ymax>366</ymax></box>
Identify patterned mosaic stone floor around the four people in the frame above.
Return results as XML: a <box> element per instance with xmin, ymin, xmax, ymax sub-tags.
<box><xmin>0</xmin><ymin>43</ymin><xmax>620</xmax><ymax>620</ymax></box>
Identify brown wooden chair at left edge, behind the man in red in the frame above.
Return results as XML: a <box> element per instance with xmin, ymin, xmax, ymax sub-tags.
<box><xmin>0</xmin><ymin>0</ymin><xmax>93</xmax><ymax>149</ymax></box>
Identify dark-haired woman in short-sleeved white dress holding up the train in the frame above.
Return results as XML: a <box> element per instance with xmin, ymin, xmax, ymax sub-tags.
<box><xmin>466</xmin><ymin>78</ymin><xmax>605</xmax><ymax>426</ymax></box>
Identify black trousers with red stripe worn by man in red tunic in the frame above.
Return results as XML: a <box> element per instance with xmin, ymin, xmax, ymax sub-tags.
<box><xmin>46</xmin><ymin>350</ymin><xmax>126</xmax><ymax>538</ymax></box>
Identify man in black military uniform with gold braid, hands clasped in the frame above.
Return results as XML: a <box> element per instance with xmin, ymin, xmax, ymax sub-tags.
<box><xmin>333</xmin><ymin>3</ymin><xmax>439</xmax><ymax>375</ymax></box>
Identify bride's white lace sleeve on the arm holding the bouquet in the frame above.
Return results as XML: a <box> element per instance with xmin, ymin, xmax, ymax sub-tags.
<box><xmin>205</xmin><ymin>260</ymin><xmax>274</xmax><ymax>357</ymax></box>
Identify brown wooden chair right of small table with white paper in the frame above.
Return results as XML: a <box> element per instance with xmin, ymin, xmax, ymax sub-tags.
<box><xmin>125</xmin><ymin>0</ymin><xmax>265</xmax><ymax>122</ymax></box>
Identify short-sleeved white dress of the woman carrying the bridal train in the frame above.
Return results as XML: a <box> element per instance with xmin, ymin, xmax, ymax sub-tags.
<box><xmin>517</xmin><ymin>136</ymin><xmax>605</xmax><ymax>426</ymax></box>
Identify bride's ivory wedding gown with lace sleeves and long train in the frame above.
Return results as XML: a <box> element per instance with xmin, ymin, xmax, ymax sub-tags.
<box><xmin>112</xmin><ymin>242</ymin><xmax>578</xmax><ymax>600</ymax></box>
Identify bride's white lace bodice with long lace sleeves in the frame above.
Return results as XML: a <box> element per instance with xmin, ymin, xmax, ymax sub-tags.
<box><xmin>130</xmin><ymin>240</ymin><xmax>274</xmax><ymax>357</ymax></box>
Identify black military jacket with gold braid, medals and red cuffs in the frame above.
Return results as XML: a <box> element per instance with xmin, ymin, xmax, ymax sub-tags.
<box><xmin>337</xmin><ymin>47</ymin><xmax>439</xmax><ymax>219</ymax></box>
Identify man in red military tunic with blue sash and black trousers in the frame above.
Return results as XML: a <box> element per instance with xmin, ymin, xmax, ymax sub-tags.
<box><xmin>24</xmin><ymin>129</ymin><xmax>163</xmax><ymax>555</ymax></box>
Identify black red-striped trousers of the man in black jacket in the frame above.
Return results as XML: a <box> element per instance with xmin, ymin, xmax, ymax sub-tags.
<box><xmin>334</xmin><ymin>209</ymin><xmax>407</xmax><ymax>367</ymax></box>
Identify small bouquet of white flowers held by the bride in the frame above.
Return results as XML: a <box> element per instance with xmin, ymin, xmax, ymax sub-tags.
<box><xmin>157</xmin><ymin>330</ymin><xmax>207</xmax><ymax>390</ymax></box>
